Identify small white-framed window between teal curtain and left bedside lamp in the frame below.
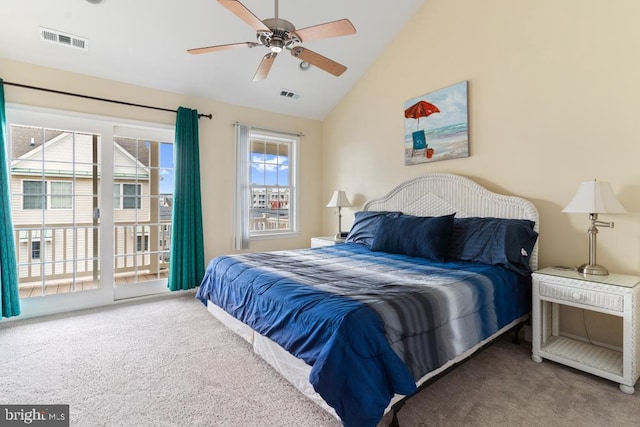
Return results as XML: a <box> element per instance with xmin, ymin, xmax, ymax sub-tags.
<box><xmin>238</xmin><ymin>129</ymin><xmax>298</xmax><ymax>238</ymax></box>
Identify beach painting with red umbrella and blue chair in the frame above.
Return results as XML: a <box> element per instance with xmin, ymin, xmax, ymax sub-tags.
<box><xmin>404</xmin><ymin>81</ymin><xmax>469</xmax><ymax>166</ymax></box>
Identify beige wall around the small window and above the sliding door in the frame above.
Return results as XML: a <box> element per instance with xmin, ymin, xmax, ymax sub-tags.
<box><xmin>0</xmin><ymin>58</ymin><xmax>326</xmax><ymax>260</ymax></box>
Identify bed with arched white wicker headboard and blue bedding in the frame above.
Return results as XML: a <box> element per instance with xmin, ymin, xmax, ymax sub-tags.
<box><xmin>196</xmin><ymin>173</ymin><xmax>539</xmax><ymax>427</ymax></box>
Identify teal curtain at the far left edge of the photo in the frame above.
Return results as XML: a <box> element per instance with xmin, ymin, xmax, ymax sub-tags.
<box><xmin>0</xmin><ymin>79</ymin><xmax>20</xmax><ymax>318</ymax></box>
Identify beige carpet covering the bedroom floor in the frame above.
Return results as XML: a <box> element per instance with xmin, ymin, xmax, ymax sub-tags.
<box><xmin>0</xmin><ymin>293</ymin><xmax>640</xmax><ymax>427</ymax></box>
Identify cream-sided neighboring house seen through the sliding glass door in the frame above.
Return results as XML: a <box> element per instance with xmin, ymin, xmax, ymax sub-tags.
<box><xmin>11</xmin><ymin>126</ymin><xmax>172</xmax><ymax>285</ymax></box>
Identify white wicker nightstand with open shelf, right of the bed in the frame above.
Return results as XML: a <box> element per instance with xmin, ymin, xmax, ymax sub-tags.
<box><xmin>531</xmin><ymin>267</ymin><xmax>640</xmax><ymax>394</ymax></box>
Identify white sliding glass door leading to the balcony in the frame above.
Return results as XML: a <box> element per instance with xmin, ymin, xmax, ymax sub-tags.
<box><xmin>7</xmin><ymin>104</ymin><xmax>173</xmax><ymax>316</ymax></box>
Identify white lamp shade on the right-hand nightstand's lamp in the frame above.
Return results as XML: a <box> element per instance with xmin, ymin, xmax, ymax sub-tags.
<box><xmin>562</xmin><ymin>180</ymin><xmax>627</xmax><ymax>213</ymax></box>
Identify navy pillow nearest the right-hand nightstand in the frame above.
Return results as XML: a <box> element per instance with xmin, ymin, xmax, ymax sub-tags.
<box><xmin>447</xmin><ymin>217</ymin><xmax>538</xmax><ymax>275</ymax></box>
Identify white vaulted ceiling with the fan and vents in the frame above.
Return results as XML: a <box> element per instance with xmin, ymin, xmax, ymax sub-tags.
<box><xmin>0</xmin><ymin>0</ymin><xmax>425</xmax><ymax>119</ymax></box>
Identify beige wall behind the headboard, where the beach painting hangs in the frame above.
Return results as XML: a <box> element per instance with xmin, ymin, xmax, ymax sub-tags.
<box><xmin>323</xmin><ymin>0</ymin><xmax>640</xmax><ymax>343</ymax></box>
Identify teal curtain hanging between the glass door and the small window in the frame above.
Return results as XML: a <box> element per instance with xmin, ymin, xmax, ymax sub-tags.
<box><xmin>168</xmin><ymin>107</ymin><xmax>204</xmax><ymax>291</ymax></box>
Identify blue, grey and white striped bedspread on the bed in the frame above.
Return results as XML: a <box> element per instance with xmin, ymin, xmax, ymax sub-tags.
<box><xmin>196</xmin><ymin>243</ymin><xmax>531</xmax><ymax>427</ymax></box>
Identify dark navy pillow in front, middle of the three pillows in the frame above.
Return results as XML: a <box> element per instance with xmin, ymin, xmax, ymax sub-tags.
<box><xmin>371</xmin><ymin>214</ymin><xmax>455</xmax><ymax>262</ymax></box>
